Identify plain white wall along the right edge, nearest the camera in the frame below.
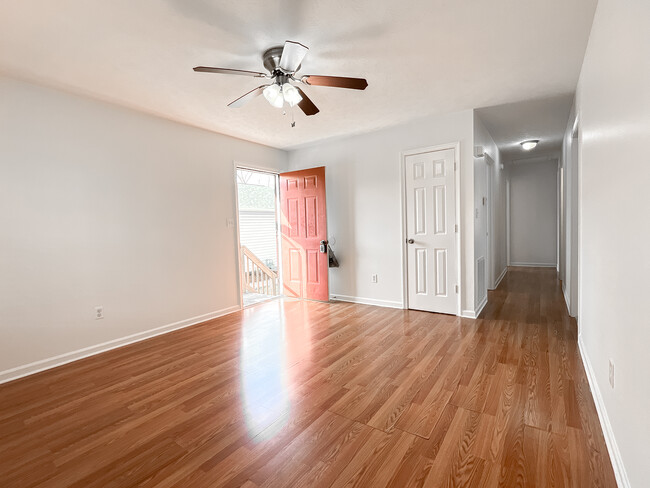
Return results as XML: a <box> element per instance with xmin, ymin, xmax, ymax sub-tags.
<box><xmin>577</xmin><ymin>0</ymin><xmax>650</xmax><ymax>487</ymax></box>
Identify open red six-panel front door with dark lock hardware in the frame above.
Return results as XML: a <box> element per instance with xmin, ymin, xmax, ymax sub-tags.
<box><xmin>280</xmin><ymin>167</ymin><xmax>329</xmax><ymax>301</ymax></box>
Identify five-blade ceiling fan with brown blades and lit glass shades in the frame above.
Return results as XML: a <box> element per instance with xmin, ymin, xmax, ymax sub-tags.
<box><xmin>194</xmin><ymin>41</ymin><xmax>368</xmax><ymax>117</ymax></box>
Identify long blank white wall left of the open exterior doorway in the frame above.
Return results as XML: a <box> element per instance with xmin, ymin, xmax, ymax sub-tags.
<box><xmin>0</xmin><ymin>77</ymin><xmax>287</xmax><ymax>380</ymax></box>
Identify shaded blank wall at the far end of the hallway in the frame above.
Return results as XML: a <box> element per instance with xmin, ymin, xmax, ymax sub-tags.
<box><xmin>508</xmin><ymin>160</ymin><xmax>558</xmax><ymax>266</ymax></box>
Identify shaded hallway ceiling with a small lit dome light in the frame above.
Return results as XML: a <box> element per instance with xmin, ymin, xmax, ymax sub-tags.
<box><xmin>476</xmin><ymin>94</ymin><xmax>573</xmax><ymax>161</ymax></box>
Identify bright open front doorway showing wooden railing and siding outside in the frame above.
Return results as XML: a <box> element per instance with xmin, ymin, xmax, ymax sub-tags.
<box><xmin>236</xmin><ymin>167</ymin><xmax>282</xmax><ymax>307</ymax></box>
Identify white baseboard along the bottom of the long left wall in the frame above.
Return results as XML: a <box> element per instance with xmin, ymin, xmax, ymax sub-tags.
<box><xmin>0</xmin><ymin>305</ymin><xmax>240</xmax><ymax>384</ymax></box>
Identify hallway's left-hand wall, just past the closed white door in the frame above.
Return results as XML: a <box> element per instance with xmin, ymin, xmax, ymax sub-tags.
<box><xmin>474</xmin><ymin>111</ymin><xmax>508</xmax><ymax>296</ymax></box>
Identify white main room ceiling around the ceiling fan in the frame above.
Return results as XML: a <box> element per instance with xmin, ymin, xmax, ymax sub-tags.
<box><xmin>0</xmin><ymin>0</ymin><xmax>596</xmax><ymax>148</ymax></box>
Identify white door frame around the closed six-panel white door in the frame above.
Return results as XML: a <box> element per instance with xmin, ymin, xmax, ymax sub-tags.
<box><xmin>400</xmin><ymin>141</ymin><xmax>463</xmax><ymax>316</ymax></box>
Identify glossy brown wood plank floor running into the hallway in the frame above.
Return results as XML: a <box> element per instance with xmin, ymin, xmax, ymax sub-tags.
<box><xmin>0</xmin><ymin>268</ymin><xmax>616</xmax><ymax>488</ymax></box>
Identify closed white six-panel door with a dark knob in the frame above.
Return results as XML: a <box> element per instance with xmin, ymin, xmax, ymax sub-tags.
<box><xmin>405</xmin><ymin>149</ymin><xmax>458</xmax><ymax>314</ymax></box>
